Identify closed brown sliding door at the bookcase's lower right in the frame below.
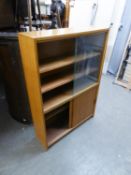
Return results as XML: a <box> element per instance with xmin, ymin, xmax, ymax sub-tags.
<box><xmin>71</xmin><ymin>87</ymin><xmax>98</xmax><ymax>127</ymax></box>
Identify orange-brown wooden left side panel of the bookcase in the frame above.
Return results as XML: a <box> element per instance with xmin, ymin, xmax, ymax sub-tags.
<box><xmin>19</xmin><ymin>34</ymin><xmax>47</xmax><ymax>148</ymax></box>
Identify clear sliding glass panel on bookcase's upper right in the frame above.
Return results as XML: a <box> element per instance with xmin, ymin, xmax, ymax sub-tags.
<box><xmin>73</xmin><ymin>33</ymin><xmax>105</xmax><ymax>92</ymax></box>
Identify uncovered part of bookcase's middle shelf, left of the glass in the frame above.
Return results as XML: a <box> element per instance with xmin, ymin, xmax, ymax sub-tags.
<box><xmin>41</xmin><ymin>74</ymin><xmax>73</xmax><ymax>93</ymax></box>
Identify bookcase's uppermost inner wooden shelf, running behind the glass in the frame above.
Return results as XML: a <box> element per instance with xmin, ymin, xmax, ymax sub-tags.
<box><xmin>39</xmin><ymin>52</ymin><xmax>100</xmax><ymax>73</ymax></box>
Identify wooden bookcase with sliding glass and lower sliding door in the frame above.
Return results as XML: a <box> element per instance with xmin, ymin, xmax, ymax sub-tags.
<box><xmin>19</xmin><ymin>28</ymin><xmax>108</xmax><ymax>149</ymax></box>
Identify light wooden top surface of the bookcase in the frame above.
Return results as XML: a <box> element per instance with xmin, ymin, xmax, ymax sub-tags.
<box><xmin>19</xmin><ymin>27</ymin><xmax>109</xmax><ymax>41</ymax></box>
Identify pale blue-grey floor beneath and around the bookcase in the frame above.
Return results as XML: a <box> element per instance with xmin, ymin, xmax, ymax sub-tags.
<box><xmin>0</xmin><ymin>76</ymin><xmax>131</xmax><ymax>175</ymax></box>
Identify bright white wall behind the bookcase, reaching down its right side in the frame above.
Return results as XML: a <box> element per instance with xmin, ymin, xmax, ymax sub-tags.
<box><xmin>69</xmin><ymin>0</ymin><xmax>126</xmax><ymax>73</ymax></box>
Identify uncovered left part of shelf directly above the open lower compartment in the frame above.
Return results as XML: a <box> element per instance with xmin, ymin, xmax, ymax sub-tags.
<box><xmin>43</xmin><ymin>90</ymin><xmax>72</xmax><ymax>114</ymax></box>
